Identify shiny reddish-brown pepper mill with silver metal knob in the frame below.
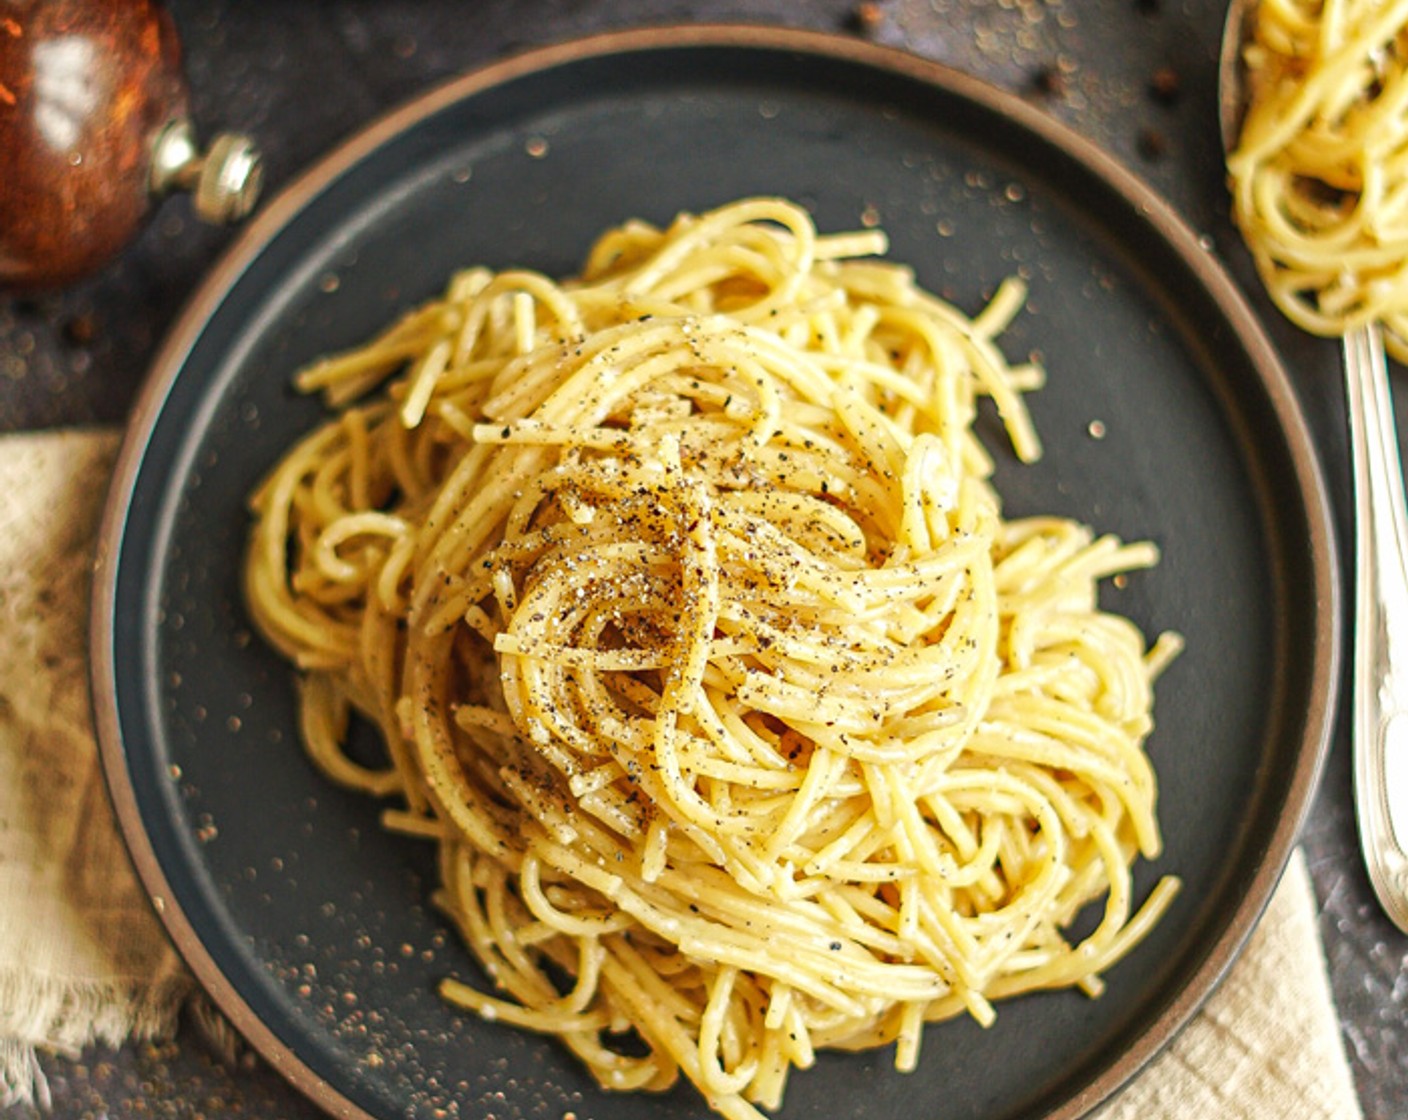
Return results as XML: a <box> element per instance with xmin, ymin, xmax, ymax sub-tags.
<box><xmin>0</xmin><ymin>0</ymin><xmax>260</xmax><ymax>289</ymax></box>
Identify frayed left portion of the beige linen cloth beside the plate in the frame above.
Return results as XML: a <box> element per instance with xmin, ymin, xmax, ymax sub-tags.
<box><xmin>0</xmin><ymin>433</ymin><xmax>190</xmax><ymax>1106</ymax></box>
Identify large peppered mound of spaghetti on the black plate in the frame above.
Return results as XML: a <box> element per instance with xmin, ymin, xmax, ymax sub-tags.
<box><xmin>245</xmin><ymin>199</ymin><xmax>1177</xmax><ymax>1120</ymax></box>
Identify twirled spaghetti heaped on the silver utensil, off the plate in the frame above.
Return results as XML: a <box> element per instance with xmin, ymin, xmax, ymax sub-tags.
<box><xmin>1228</xmin><ymin>0</ymin><xmax>1408</xmax><ymax>361</ymax></box>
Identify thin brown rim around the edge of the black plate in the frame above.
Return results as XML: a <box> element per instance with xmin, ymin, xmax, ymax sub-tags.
<box><xmin>89</xmin><ymin>23</ymin><xmax>1343</xmax><ymax>1120</ymax></box>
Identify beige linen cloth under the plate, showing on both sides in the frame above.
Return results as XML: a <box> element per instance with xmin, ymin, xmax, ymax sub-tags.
<box><xmin>0</xmin><ymin>433</ymin><xmax>1360</xmax><ymax>1120</ymax></box>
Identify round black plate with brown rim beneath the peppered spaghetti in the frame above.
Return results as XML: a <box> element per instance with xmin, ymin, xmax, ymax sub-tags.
<box><xmin>93</xmin><ymin>28</ymin><xmax>1338</xmax><ymax>1120</ymax></box>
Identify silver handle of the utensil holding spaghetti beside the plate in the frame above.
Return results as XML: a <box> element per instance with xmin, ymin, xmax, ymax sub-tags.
<box><xmin>1345</xmin><ymin>325</ymin><xmax>1408</xmax><ymax>933</ymax></box>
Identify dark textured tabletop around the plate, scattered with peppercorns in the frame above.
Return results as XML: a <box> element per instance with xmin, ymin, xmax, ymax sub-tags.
<box><xmin>0</xmin><ymin>0</ymin><xmax>1408</xmax><ymax>1120</ymax></box>
